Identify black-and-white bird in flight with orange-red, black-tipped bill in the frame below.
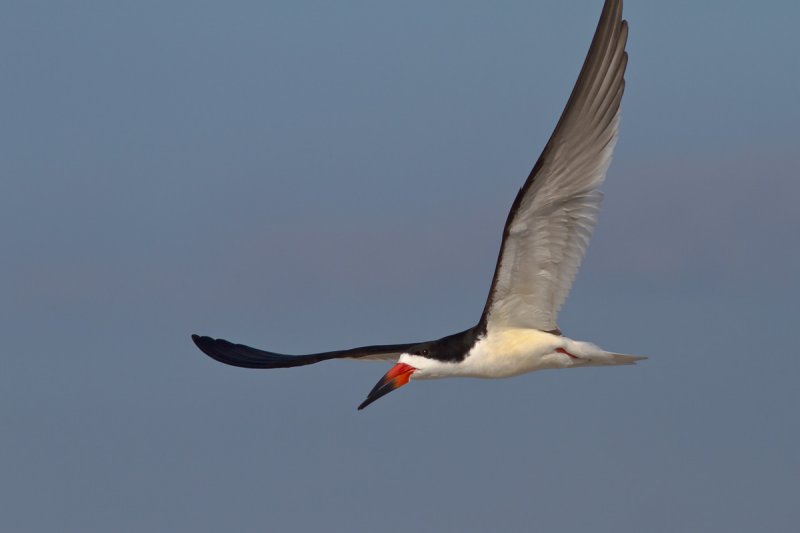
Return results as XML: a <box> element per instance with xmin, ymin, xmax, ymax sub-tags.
<box><xmin>192</xmin><ymin>0</ymin><xmax>644</xmax><ymax>409</ymax></box>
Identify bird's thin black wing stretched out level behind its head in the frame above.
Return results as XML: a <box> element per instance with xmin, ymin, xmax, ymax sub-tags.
<box><xmin>192</xmin><ymin>335</ymin><xmax>418</xmax><ymax>368</ymax></box>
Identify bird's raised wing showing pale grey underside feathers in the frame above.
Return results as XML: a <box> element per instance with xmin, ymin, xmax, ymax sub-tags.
<box><xmin>481</xmin><ymin>0</ymin><xmax>628</xmax><ymax>331</ymax></box>
